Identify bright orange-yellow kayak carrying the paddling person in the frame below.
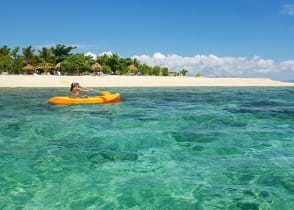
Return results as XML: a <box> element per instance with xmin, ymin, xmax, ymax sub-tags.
<box><xmin>48</xmin><ymin>91</ymin><xmax>120</xmax><ymax>105</ymax></box>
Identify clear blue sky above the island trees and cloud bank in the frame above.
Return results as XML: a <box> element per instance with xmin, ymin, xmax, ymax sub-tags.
<box><xmin>0</xmin><ymin>0</ymin><xmax>294</xmax><ymax>78</ymax></box>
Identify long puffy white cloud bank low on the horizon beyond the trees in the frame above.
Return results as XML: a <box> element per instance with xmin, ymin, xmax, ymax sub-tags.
<box><xmin>133</xmin><ymin>52</ymin><xmax>294</xmax><ymax>79</ymax></box>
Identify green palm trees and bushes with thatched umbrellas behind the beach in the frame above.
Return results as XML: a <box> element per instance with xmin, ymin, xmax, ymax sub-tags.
<box><xmin>0</xmin><ymin>44</ymin><xmax>181</xmax><ymax>76</ymax></box>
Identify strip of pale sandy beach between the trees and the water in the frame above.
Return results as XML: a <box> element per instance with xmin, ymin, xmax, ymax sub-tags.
<box><xmin>0</xmin><ymin>75</ymin><xmax>294</xmax><ymax>88</ymax></box>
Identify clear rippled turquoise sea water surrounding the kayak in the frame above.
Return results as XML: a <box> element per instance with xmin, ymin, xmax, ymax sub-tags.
<box><xmin>0</xmin><ymin>88</ymin><xmax>294</xmax><ymax>210</ymax></box>
